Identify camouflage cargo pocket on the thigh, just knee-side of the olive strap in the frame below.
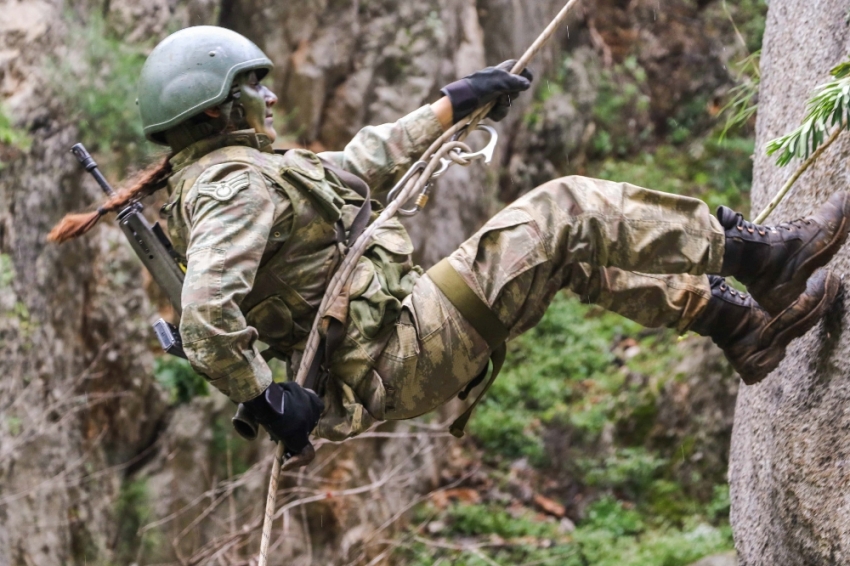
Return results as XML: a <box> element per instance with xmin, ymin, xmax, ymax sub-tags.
<box><xmin>460</xmin><ymin>208</ymin><xmax>549</xmax><ymax>306</ymax></box>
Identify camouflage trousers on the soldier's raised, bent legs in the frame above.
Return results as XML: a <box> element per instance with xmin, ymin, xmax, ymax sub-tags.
<box><xmin>374</xmin><ymin>177</ymin><xmax>725</xmax><ymax>419</ymax></box>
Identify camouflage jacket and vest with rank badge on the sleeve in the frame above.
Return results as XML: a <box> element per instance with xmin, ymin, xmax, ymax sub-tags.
<box><xmin>163</xmin><ymin>106</ymin><xmax>442</xmax><ymax>439</ymax></box>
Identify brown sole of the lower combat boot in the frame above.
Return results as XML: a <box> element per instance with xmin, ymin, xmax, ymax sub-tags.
<box><xmin>735</xmin><ymin>271</ymin><xmax>841</xmax><ymax>385</ymax></box>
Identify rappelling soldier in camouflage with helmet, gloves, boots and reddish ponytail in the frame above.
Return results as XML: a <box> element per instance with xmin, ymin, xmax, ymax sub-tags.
<box><xmin>53</xmin><ymin>26</ymin><xmax>850</xmax><ymax>460</ymax></box>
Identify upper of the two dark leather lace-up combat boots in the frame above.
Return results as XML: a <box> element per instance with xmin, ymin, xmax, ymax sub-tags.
<box><xmin>717</xmin><ymin>191</ymin><xmax>850</xmax><ymax>315</ymax></box>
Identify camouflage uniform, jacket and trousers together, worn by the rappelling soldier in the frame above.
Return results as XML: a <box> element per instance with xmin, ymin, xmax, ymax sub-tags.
<box><xmin>164</xmin><ymin>107</ymin><xmax>724</xmax><ymax>440</ymax></box>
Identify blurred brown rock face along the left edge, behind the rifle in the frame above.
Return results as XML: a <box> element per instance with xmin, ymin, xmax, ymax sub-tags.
<box><xmin>0</xmin><ymin>2</ymin><xmax>172</xmax><ymax>564</ymax></box>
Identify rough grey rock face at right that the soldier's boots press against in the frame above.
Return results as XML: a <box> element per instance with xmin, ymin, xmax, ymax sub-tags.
<box><xmin>730</xmin><ymin>0</ymin><xmax>850</xmax><ymax>566</ymax></box>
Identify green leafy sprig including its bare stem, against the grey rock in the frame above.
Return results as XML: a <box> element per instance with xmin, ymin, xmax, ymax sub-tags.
<box><xmin>755</xmin><ymin>60</ymin><xmax>850</xmax><ymax>224</ymax></box>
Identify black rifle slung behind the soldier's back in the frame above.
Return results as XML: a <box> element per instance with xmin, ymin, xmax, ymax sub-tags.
<box><xmin>71</xmin><ymin>143</ymin><xmax>259</xmax><ymax>440</ymax></box>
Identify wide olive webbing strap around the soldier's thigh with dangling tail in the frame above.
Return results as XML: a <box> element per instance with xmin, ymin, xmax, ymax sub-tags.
<box><xmin>427</xmin><ymin>259</ymin><xmax>510</xmax><ymax>438</ymax></box>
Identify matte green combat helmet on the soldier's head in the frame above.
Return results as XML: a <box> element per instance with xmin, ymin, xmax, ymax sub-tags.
<box><xmin>138</xmin><ymin>26</ymin><xmax>274</xmax><ymax>144</ymax></box>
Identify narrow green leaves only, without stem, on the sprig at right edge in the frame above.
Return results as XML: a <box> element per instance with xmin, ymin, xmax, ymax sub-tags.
<box><xmin>767</xmin><ymin>55</ymin><xmax>850</xmax><ymax>167</ymax></box>
